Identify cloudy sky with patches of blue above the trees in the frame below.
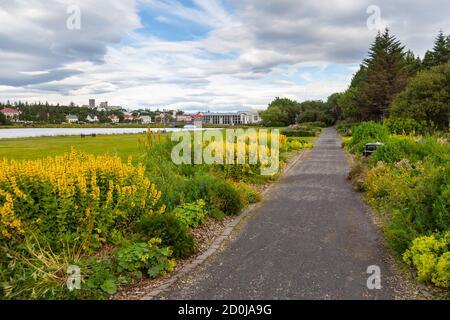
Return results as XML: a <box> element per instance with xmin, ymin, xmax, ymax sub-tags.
<box><xmin>0</xmin><ymin>0</ymin><xmax>450</xmax><ymax>111</ymax></box>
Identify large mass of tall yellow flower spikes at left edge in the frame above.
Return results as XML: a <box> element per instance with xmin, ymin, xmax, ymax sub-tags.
<box><xmin>0</xmin><ymin>149</ymin><xmax>164</xmax><ymax>239</ymax></box>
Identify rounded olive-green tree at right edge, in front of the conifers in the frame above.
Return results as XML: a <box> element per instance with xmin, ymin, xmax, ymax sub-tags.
<box><xmin>390</xmin><ymin>62</ymin><xmax>450</xmax><ymax>129</ymax></box>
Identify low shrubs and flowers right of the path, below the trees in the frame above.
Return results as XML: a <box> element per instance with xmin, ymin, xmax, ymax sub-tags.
<box><xmin>339</xmin><ymin>119</ymin><xmax>450</xmax><ymax>289</ymax></box>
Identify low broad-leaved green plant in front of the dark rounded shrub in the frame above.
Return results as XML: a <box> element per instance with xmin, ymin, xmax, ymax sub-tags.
<box><xmin>115</xmin><ymin>238</ymin><xmax>176</xmax><ymax>278</ymax></box>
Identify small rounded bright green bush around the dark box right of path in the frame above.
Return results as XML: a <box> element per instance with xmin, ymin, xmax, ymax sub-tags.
<box><xmin>350</xmin><ymin>122</ymin><xmax>389</xmax><ymax>153</ymax></box>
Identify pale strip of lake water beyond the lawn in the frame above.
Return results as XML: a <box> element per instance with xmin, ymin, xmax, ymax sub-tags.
<box><xmin>0</xmin><ymin>128</ymin><xmax>204</xmax><ymax>139</ymax></box>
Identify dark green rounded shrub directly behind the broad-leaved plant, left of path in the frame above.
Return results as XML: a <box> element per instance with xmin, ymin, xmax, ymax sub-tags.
<box><xmin>138</xmin><ymin>213</ymin><xmax>196</xmax><ymax>258</ymax></box>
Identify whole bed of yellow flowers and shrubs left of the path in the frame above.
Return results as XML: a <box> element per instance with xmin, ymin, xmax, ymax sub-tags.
<box><xmin>0</xmin><ymin>130</ymin><xmax>312</xmax><ymax>299</ymax></box>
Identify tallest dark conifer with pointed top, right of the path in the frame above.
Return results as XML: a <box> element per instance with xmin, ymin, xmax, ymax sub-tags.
<box><xmin>359</xmin><ymin>29</ymin><xmax>408</xmax><ymax>121</ymax></box>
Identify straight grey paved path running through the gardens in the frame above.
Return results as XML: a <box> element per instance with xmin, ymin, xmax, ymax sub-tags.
<box><xmin>158</xmin><ymin>128</ymin><xmax>394</xmax><ymax>299</ymax></box>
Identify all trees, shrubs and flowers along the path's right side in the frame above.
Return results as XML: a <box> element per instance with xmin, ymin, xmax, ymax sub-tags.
<box><xmin>328</xmin><ymin>30</ymin><xmax>450</xmax><ymax>289</ymax></box>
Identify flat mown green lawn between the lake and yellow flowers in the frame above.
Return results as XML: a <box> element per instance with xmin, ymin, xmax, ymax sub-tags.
<box><xmin>0</xmin><ymin>134</ymin><xmax>145</xmax><ymax>161</ymax></box>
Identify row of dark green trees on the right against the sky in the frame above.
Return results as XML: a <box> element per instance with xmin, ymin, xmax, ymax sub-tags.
<box><xmin>260</xmin><ymin>29</ymin><xmax>450</xmax><ymax>129</ymax></box>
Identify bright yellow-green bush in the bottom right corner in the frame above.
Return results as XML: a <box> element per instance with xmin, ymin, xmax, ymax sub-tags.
<box><xmin>403</xmin><ymin>231</ymin><xmax>450</xmax><ymax>288</ymax></box>
